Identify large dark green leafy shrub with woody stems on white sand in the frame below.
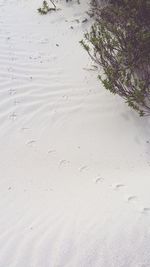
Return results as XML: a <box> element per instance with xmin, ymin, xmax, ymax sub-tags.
<box><xmin>81</xmin><ymin>0</ymin><xmax>150</xmax><ymax>116</ymax></box>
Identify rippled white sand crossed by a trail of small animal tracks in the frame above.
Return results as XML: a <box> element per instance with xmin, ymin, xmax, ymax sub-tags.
<box><xmin>0</xmin><ymin>0</ymin><xmax>150</xmax><ymax>267</ymax></box>
